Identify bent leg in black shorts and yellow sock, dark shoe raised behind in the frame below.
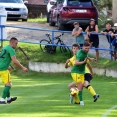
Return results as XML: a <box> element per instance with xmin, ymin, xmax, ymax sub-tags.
<box><xmin>84</xmin><ymin>73</ymin><xmax>99</xmax><ymax>102</ymax></box>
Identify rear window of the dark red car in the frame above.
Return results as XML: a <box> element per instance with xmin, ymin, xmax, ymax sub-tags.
<box><xmin>68</xmin><ymin>0</ymin><xmax>92</xmax><ymax>7</ymax></box>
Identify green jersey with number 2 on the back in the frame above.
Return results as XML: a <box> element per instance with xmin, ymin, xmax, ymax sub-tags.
<box><xmin>0</xmin><ymin>45</ymin><xmax>15</xmax><ymax>71</ymax></box>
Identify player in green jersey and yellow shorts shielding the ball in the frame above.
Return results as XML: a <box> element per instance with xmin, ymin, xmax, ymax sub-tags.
<box><xmin>71</xmin><ymin>42</ymin><xmax>90</xmax><ymax>105</ymax></box>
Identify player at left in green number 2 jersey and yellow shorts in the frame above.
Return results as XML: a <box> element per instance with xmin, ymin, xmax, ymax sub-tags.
<box><xmin>0</xmin><ymin>37</ymin><xmax>28</xmax><ymax>104</ymax></box>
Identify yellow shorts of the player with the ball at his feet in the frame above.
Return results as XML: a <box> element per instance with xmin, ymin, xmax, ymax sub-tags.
<box><xmin>71</xmin><ymin>73</ymin><xmax>84</xmax><ymax>84</ymax></box>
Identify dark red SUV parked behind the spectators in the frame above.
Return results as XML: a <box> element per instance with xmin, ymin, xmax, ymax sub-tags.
<box><xmin>48</xmin><ymin>0</ymin><xmax>98</xmax><ymax>30</ymax></box>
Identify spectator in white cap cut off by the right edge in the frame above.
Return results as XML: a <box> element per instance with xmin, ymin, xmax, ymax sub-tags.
<box><xmin>111</xmin><ymin>23</ymin><xmax>117</xmax><ymax>61</ymax></box>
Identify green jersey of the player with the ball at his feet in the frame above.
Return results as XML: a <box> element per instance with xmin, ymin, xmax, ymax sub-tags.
<box><xmin>71</xmin><ymin>50</ymin><xmax>87</xmax><ymax>74</ymax></box>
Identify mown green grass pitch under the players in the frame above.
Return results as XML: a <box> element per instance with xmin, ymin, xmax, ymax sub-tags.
<box><xmin>0</xmin><ymin>71</ymin><xmax>117</xmax><ymax>117</ymax></box>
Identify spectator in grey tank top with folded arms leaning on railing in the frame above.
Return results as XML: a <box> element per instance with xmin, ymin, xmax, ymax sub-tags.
<box><xmin>72</xmin><ymin>22</ymin><xmax>84</xmax><ymax>47</ymax></box>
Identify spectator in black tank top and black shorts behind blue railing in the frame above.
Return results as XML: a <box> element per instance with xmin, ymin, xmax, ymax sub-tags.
<box><xmin>85</xmin><ymin>19</ymin><xmax>99</xmax><ymax>61</ymax></box>
